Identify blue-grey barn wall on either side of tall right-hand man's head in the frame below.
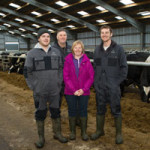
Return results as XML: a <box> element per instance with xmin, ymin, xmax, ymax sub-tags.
<box><xmin>73</xmin><ymin>25</ymin><xmax>150</xmax><ymax>51</ymax></box>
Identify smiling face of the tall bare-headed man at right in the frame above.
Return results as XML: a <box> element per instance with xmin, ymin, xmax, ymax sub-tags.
<box><xmin>100</xmin><ymin>28</ymin><xmax>112</xmax><ymax>42</ymax></box>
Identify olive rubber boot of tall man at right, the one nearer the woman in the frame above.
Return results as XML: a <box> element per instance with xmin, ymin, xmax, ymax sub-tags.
<box><xmin>91</xmin><ymin>115</ymin><xmax>105</xmax><ymax>140</ymax></box>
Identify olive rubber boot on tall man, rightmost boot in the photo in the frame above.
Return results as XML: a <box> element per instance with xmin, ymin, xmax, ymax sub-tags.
<box><xmin>115</xmin><ymin>116</ymin><xmax>123</xmax><ymax>144</ymax></box>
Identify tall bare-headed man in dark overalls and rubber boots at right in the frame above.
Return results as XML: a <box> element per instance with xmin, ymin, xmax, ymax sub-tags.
<box><xmin>91</xmin><ymin>25</ymin><xmax>128</xmax><ymax>144</ymax></box>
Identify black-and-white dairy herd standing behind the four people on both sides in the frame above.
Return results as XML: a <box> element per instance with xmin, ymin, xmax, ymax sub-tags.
<box><xmin>0</xmin><ymin>51</ymin><xmax>150</xmax><ymax>103</ymax></box>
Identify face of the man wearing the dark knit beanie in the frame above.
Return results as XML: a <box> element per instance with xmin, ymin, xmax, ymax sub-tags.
<box><xmin>38</xmin><ymin>33</ymin><xmax>50</xmax><ymax>47</ymax></box>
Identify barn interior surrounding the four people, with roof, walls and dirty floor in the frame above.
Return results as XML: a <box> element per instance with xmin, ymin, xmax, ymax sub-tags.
<box><xmin>0</xmin><ymin>0</ymin><xmax>150</xmax><ymax>150</ymax></box>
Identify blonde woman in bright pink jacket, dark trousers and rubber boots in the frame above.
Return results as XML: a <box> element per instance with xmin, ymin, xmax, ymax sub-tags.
<box><xmin>63</xmin><ymin>40</ymin><xmax>94</xmax><ymax>141</ymax></box>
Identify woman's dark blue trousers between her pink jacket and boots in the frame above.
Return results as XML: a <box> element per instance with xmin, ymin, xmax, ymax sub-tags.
<box><xmin>66</xmin><ymin>95</ymin><xmax>89</xmax><ymax>117</ymax></box>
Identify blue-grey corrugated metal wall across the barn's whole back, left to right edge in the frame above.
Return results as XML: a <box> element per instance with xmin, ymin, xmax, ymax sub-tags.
<box><xmin>0</xmin><ymin>25</ymin><xmax>150</xmax><ymax>51</ymax></box>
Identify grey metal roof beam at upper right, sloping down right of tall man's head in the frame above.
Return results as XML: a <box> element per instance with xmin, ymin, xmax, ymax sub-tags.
<box><xmin>90</xmin><ymin>0</ymin><xmax>144</xmax><ymax>32</ymax></box>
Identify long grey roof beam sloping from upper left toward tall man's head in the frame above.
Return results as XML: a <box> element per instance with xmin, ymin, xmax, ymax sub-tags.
<box><xmin>21</xmin><ymin>0</ymin><xmax>99</xmax><ymax>32</ymax></box>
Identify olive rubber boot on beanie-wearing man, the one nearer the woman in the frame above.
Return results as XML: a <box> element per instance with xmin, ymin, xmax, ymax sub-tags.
<box><xmin>52</xmin><ymin>118</ymin><xmax>68</xmax><ymax>143</ymax></box>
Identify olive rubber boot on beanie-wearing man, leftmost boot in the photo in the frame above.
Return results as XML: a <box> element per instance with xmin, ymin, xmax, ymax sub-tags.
<box><xmin>35</xmin><ymin>120</ymin><xmax>45</xmax><ymax>148</ymax></box>
